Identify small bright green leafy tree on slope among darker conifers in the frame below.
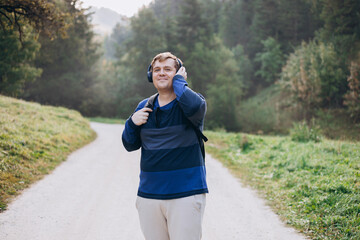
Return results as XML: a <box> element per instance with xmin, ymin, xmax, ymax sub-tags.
<box><xmin>255</xmin><ymin>37</ymin><xmax>284</xmax><ymax>83</ymax></box>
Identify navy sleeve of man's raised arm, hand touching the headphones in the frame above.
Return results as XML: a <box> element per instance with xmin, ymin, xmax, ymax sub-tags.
<box><xmin>173</xmin><ymin>75</ymin><xmax>206</xmax><ymax>128</ymax></box>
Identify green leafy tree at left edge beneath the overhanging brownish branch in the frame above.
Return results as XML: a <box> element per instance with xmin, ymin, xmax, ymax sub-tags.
<box><xmin>0</xmin><ymin>21</ymin><xmax>42</xmax><ymax>96</ymax></box>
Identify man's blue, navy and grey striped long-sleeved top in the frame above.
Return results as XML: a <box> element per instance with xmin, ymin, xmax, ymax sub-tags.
<box><xmin>122</xmin><ymin>75</ymin><xmax>208</xmax><ymax>199</ymax></box>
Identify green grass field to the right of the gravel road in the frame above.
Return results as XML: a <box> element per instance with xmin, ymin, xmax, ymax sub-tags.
<box><xmin>206</xmin><ymin>131</ymin><xmax>360</xmax><ymax>239</ymax></box>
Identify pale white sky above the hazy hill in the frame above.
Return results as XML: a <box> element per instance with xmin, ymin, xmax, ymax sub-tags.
<box><xmin>82</xmin><ymin>0</ymin><xmax>152</xmax><ymax>17</ymax></box>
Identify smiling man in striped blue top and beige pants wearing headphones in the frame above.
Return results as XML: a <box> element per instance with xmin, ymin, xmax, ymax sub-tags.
<box><xmin>122</xmin><ymin>52</ymin><xmax>208</xmax><ymax>240</ymax></box>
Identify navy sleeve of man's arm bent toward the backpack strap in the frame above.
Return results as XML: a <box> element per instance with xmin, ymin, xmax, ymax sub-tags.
<box><xmin>122</xmin><ymin>99</ymin><xmax>147</xmax><ymax>152</ymax></box>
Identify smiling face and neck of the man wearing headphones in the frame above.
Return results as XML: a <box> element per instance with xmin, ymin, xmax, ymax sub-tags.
<box><xmin>152</xmin><ymin>58</ymin><xmax>176</xmax><ymax>91</ymax></box>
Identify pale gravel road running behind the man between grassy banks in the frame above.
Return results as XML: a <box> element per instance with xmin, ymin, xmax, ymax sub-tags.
<box><xmin>0</xmin><ymin>123</ymin><xmax>305</xmax><ymax>240</ymax></box>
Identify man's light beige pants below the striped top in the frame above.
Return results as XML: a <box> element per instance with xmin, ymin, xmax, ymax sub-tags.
<box><xmin>136</xmin><ymin>194</ymin><xmax>206</xmax><ymax>240</ymax></box>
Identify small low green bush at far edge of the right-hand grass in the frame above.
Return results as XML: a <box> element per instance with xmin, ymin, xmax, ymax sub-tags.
<box><xmin>290</xmin><ymin>119</ymin><xmax>322</xmax><ymax>142</ymax></box>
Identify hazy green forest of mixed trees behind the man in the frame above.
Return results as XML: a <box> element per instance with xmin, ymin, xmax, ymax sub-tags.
<box><xmin>0</xmin><ymin>0</ymin><xmax>360</xmax><ymax>137</ymax></box>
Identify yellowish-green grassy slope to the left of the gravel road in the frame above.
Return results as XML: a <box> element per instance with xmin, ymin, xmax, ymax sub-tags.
<box><xmin>0</xmin><ymin>95</ymin><xmax>95</xmax><ymax>212</ymax></box>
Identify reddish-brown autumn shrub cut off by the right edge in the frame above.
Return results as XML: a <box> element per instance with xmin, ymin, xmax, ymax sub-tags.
<box><xmin>344</xmin><ymin>62</ymin><xmax>360</xmax><ymax>121</ymax></box>
